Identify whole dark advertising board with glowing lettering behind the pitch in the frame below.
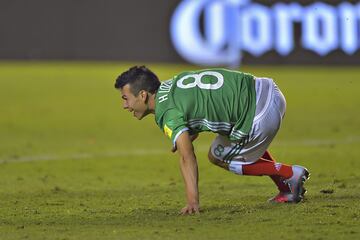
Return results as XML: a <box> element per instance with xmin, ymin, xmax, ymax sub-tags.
<box><xmin>0</xmin><ymin>0</ymin><xmax>360</xmax><ymax>64</ymax></box>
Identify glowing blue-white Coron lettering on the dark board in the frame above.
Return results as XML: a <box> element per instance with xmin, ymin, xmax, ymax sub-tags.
<box><xmin>171</xmin><ymin>0</ymin><xmax>360</xmax><ymax>66</ymax></box>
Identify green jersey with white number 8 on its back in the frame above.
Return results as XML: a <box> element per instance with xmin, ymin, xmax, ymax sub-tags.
<box><xmin>155</xmin><ymin>69</ymin><xmax>256</xmax><ymax>145</ymax></box>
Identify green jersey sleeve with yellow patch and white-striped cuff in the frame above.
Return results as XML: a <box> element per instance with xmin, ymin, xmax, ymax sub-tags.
<box><xmin>162</xmin><ymin>109</ymin><xmax>189</xmax><ymax>146</ymax></box>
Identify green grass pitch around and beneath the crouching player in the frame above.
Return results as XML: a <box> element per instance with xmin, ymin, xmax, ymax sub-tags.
<box><xmin>0</xmin><ymin>62</ymin><xmax>360</xmax><ymax>239</ymax></box>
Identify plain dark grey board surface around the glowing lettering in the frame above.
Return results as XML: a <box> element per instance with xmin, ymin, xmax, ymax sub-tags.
<box><xmin>0</xmin><ymin>0</ymin><xmax>360</xmax><ymax>64</ymax></box>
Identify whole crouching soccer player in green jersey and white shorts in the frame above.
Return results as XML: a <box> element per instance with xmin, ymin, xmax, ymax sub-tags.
<box><xmin>115</xmin><ymin>66</ymin><xmax>309</xmax><ymax>214</ymax></box>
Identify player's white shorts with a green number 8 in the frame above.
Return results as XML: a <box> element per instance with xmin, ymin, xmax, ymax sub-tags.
<box><xmin>211</xmin><ymin>78</ymin><xmax>286</xmax><ymax>170</ymax></box>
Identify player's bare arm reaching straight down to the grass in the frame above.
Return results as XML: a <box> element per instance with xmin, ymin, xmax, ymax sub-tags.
<box><xmin>176</xmin><ymin>131</ymin><xmax>199</xmax><ymax>215</ymax></box>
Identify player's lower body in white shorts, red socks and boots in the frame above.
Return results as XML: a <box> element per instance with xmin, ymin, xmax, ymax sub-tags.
<box><xmin>209</xmin><ymin>79</ymin><xmax>309</xmax><ymax>202</ymax></box>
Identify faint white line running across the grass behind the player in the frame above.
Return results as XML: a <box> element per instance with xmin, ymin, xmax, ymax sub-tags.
<box><xmin>0</xmin><ymin>136</ymin><xmax>360</xmax><ymax>164</ymax></box>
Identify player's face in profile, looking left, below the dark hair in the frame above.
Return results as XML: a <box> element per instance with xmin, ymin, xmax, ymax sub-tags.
<box><xmin>120</xmin><ymin>84</ymin><xmax>148</xmax><ymax>120</ymax></box>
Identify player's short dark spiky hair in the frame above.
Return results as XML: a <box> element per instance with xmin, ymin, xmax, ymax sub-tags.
<box><xmin>115</xmin><ymin>66</ymin><xmax>160</xmax><ymax>96</ymax></box>
